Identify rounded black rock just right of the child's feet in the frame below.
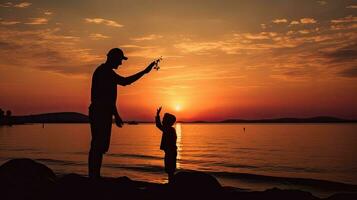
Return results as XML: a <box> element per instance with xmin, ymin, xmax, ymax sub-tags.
<box><xmin>171</xmin><ymin>171</ymin><xmax>222</xmax><ymax>196</ymax></box>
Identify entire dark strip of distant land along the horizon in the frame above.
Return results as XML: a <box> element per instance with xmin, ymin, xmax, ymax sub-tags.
<box><xmin>3</xmin><ymin>112</ymin><xmax>357</xmax><ymax>125</ymax></box>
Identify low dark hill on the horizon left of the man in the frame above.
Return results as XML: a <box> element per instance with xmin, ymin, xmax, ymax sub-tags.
<box><xmin>11</xmin><ymin>112</ymin><xmax>89</xmax><ymax>124</ymax></box>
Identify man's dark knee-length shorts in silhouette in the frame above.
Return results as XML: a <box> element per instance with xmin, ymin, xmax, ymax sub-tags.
<box><xmin>89</xmin><ymin>105</ymin><xmax>113</xmax><ymax>154</ymax></box>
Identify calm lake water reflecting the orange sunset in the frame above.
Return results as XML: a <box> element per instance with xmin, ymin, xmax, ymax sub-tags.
<box><xmin>0</xmin><ymin>124</ymin><xmax>357</xmax><ymax>193</ymax></box>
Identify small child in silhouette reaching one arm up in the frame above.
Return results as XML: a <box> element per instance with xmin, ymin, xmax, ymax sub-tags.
<box><xmin>155</xmin><ymin>107</ymin><xmax>177</xmax><ymax>183</ymax></box>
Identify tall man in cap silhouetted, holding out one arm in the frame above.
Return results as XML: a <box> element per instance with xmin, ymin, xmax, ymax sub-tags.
<box><xmin>88</xmin><ymin>48</ymin><xmax>156</xmax><ymax>179</ymax></box>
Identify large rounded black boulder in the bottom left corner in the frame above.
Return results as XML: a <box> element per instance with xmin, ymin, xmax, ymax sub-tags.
<box><xmin>0</xmin><ymin>158</ymin><xmax>57</xmax><ymax>199</ymax></box>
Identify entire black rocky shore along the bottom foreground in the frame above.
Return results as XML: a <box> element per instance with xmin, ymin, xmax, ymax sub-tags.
<box><xmin>0</xmin><ymin>159</ymin><xmax>357</xmax><ymax>200</ymax></box>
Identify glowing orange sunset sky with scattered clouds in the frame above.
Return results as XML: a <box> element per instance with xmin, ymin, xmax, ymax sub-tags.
<box><xmin>0</xmin><ymin>0</ymin><xmax>357</xmax><ymax>120</ymax></box>
